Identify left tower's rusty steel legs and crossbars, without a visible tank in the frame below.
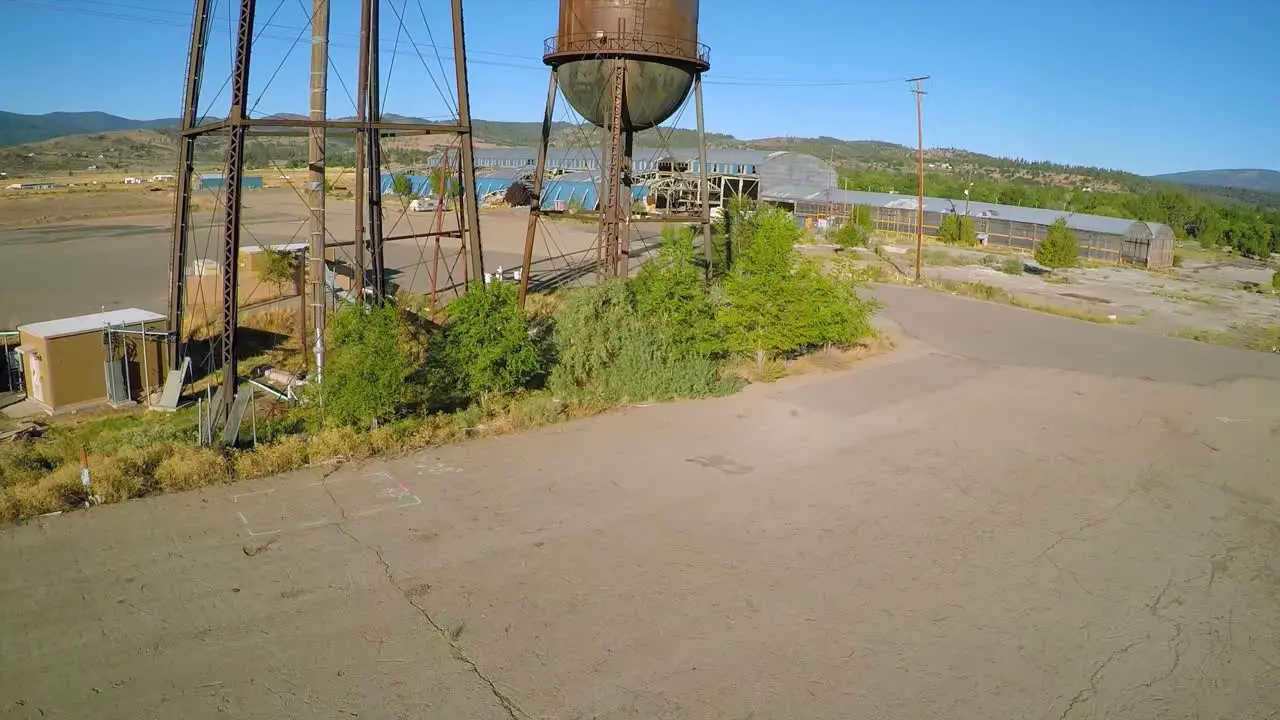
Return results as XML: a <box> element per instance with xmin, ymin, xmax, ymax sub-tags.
<box><xmin>163</xmin><ymin>0</ymin><xmax>484</xmax><ymax>442</ymax></box>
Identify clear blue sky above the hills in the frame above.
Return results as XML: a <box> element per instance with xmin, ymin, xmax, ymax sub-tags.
<box><xmin>0</xmin><ymin>0</ymin><xmax>1280</xmax><ymax>173</ymax></box>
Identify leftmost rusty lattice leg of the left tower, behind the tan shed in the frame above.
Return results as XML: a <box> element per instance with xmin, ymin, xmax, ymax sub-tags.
<box><xmin>168</xmin><ymin>0</ymin><xmax>212</xmax><ymax>370</ymax></box>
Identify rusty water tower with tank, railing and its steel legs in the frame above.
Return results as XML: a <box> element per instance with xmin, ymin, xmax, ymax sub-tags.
<box><xmin>521</xmin><ymin>0</ymin><xmax>710</xmax><ymax>299</ymax></box>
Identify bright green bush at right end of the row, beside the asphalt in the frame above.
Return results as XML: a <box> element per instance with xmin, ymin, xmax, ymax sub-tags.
<box><xmin>719</xmin><ymin>204</ymin><xmax>872</xmax><ymax>368</ymax></box>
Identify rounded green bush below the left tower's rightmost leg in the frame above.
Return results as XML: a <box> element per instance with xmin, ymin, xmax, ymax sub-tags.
<box><xmin>428</xmin><ymin>282</ymin><xmax>543</xmax><ymax>401</ymax></box>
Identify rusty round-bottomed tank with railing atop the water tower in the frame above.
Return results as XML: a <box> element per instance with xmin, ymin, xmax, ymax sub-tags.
<box><xmin>543</xmin><ymin>0</ymin><xmax>710</xmax><ymax>131</ymax></box>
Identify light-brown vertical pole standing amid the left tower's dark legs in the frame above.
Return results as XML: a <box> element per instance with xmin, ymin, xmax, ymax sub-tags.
<box><xmin>298</xmin><ymin>0</ymin><xmax>329</xmax><ymax>383</ymax></box>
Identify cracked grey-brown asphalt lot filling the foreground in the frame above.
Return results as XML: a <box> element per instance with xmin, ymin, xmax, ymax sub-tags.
<box><xmin>0</xmin><ymin>283</ymin><xmax>1280</xmax><ymax>720</ymax></box>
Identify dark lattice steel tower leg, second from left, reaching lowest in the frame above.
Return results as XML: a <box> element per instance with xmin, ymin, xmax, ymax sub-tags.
<box><xmin>220</xmin><ymin>0</ymin><xmax>257</xmax><ymax>419</ymax></box>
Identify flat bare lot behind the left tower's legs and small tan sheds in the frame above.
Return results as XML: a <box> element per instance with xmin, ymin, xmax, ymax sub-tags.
<box><xmin>0</xmin><ymin>187</ymin><xmax>659</xmax><ymax>328</ymax></box>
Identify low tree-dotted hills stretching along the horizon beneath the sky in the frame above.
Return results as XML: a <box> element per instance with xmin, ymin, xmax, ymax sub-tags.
<box><xmin>0</xmin><ymin>107</ymin><xmax>1280</xmax><ymax>208</ymax></box>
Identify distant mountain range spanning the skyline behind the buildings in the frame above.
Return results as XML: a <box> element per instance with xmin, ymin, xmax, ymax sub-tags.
<box><xmin>0</xmin><ymin>111</ymin><xmax>1280</xmax><ymax>193</ymax></box>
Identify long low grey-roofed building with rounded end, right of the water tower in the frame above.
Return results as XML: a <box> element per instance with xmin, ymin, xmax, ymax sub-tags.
<box><xmin>760</xmin><ymin>183</ymin><xmax>1174</xmax><ymax>268</ymax></box>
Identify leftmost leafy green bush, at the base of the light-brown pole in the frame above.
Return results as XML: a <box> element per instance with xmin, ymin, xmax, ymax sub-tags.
<box><xmin>320</xmin><ymin>304</ymin><xmax>415</xmax><ymax>428</ymax></box>
